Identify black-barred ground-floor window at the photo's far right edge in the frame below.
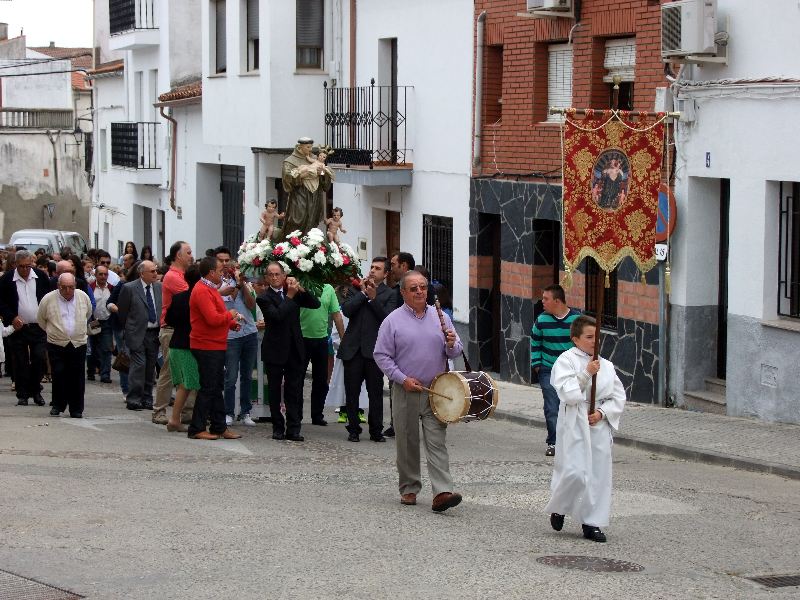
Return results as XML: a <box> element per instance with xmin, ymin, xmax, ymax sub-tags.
<box><xmin>778</xmin><ymin>183</ymin><xmax>800</xmax><ymax>318</ymax></box>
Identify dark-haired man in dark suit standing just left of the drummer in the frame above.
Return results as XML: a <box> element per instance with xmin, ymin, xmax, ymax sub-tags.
<box><xmin>338</xmin><ymin>256</ymin><xmax>394</xmax><ymax>442</ymax></box>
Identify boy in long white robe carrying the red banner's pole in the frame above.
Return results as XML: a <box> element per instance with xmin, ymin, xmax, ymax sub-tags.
<box><xmin>545</xmin><ymin>316</ymin><xmax>625</xmax><ymax>542</ymax></box>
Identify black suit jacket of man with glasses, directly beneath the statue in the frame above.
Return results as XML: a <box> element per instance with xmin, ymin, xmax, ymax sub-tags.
<box><xmin>256</xmin><ymin>287</ymin><xmax>322</xmax><ymax>365</ymax></box>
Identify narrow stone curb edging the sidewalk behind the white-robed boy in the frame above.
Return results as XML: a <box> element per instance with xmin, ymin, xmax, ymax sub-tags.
<box><xmin>492</xmin><ymin>411</ymin><xmax>800</xmax><ymax>480</ymax></box>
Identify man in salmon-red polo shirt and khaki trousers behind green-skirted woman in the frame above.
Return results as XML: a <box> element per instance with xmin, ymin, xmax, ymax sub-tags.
<box><xmin>153</xmin><ymin>242</ymin><xmax>195</xmax><ymax>425</ymax></box>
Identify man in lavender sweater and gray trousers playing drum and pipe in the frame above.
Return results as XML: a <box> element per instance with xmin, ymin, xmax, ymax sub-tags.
<box><xmin>373</xmin><ymin>271</ymin><xmax>462</xmax><ymax>512</ymax></box>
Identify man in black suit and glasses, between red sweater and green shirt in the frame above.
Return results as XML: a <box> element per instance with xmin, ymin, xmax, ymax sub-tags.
<box><xmin>256</xmin><ymin>262</ymin><xmax>320</xmax><ymax>442</ymax></box>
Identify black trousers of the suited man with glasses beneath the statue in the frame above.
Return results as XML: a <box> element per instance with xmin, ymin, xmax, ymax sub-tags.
<box><xmin>264</xmin><ymin>341</ymin><xmax>304</xmax><ymax>435</ymax></box>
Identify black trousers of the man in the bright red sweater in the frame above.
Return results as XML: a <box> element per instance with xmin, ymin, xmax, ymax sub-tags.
<box><xmin>189</xmin><ymin>348</ymin><xmax>228</xmax><ymax>435</ymax></box>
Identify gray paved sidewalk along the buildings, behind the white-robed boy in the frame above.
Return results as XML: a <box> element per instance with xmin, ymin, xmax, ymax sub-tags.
<box><xmin>494</xmin><ymin>381</ymin><xmax>800</xmax><ymax>479</ymax></box>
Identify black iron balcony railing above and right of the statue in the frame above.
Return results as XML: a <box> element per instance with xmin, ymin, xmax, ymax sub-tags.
<box><xmin>324</xmin><ymin>79</ymin><xmax>410</xmax><ymax>168</ymax></box>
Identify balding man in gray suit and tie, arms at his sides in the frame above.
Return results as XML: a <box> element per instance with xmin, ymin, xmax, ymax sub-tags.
<box><xmin>117</xmin><ymin>260</ymin><xmax>161</xmax><ymax>410</ymax></box>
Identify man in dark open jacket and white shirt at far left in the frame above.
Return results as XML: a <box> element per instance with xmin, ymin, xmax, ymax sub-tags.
<box><xmin>0</xmin><ymin>249</ymin><xmax>52</xmax><ymax>406</ymax></box>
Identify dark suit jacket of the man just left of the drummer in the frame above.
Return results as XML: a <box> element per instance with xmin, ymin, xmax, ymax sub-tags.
<box><xmin>337</xmin><ymin>283</ymin><xmax>395</xmax><ymax>360</ymax></box>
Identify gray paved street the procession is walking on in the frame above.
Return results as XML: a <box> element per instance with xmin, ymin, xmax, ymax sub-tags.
<box><xmin>0</xmin><ymin>379</ymin><xmax>800</xmax><ymax>600</ymax></box>
